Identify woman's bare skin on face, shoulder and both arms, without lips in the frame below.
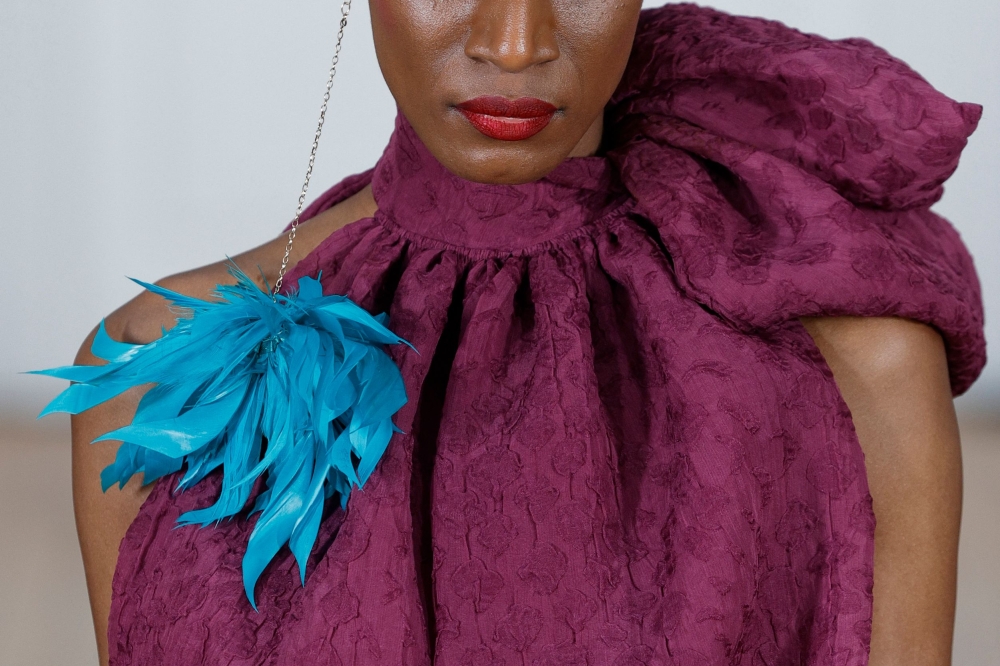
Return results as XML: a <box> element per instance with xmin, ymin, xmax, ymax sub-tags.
<box><xmin>73</xmin><ymin>0</ymin><xmax>962</xmax><ymax>666</ymax></box>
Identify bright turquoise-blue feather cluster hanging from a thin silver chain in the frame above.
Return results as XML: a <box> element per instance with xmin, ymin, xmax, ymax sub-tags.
<box><xmin>35</xmin><ymin>264</ymin><xmax>412</xmax><ymax>608</ymax></box>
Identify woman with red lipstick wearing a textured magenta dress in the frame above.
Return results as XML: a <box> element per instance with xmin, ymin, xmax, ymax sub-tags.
<box><xmin>73</xmin><ymin>0</ymin><xmax>985</xmax><ymax>666</ymax></box>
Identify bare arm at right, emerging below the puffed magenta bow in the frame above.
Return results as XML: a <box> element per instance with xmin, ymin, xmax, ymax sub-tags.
<box><xmin>803</xmin><ymin>317</ymin><xmax>962</xmax><ymax>666</ymax></box>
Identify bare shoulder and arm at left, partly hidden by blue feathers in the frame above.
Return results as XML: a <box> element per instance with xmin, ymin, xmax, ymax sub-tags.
<box><xmin>72</xmin><ymin>183</ymin><xmax>375</xmax><ymax>665</ymax></box>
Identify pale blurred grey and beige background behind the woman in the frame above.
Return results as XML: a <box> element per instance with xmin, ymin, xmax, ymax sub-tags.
<box><xmin>0</xmin><ymin>0</ymin><xmax>1000</xmax><ymax>664</ymax></box>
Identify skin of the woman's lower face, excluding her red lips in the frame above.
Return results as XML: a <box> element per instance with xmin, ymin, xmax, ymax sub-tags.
<box><xmin>370</xmin><ymin>0</ymin><xmax>642</xmax><ymax>183</ymax></box>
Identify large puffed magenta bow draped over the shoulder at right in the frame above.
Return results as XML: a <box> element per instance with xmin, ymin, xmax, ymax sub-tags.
<box><xmin>609</xmin><ymin>5</ymin><xmax>986</xmax><ymax>394</ymax></box>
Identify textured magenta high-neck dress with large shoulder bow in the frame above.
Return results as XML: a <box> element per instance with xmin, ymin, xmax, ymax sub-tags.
<box><xmin>109</xmin><ymin>5</ymin><xmax>985</xmax><ymax>666</ymax></box>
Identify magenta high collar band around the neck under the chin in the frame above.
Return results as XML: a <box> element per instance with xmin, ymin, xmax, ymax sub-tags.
<box><xmin>372</xmin><ymin>113</ymin><xmax>628</xmax><ymax>256</ymax></box>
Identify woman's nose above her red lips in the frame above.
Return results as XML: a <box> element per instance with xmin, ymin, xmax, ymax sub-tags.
<box><xmin>465</xmin><ymin>0</ymin><xmax>559</xmax><ymax>73</ymax></box>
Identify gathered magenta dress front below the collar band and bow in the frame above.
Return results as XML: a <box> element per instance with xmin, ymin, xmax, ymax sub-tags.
<box><xmin>112</xmin><ymin>204</ymin><xmax>874</xmax><ymax>664</ymax></box>
